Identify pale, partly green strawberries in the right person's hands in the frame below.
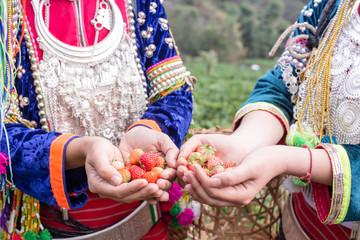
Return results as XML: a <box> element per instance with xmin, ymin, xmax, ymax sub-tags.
<box><xmin>187</xmin><ymin>144</ymin><xmax>236</xmax><ymax>177</ymax></box>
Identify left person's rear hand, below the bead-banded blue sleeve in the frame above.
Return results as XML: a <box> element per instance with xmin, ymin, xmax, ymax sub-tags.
<box><xmin>119</xmin><ymin>126</ymin><xmax>179</xmax><ymax>203</ymax></box>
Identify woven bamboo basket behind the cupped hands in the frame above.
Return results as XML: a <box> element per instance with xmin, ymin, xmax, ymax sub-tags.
<box><xmin>169</xmin><ymin>127</ymin><xmax>286</xmax><ymax>240</ymax></box>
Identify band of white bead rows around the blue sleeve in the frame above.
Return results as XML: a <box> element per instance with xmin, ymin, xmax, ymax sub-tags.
<box><xmin>146</xmin><ymin>56</ymin><xmax>190</xmax><ymax>96</ymax></box>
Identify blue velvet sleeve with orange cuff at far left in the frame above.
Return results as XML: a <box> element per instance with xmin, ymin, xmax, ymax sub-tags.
<box><xmin>1</xmin><ymin>123</ymin><xmax>87</xmax><ymax>209</ymax></box>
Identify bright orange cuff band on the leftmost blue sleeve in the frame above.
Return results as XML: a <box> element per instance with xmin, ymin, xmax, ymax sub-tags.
<box><xmin>49</xmin><ymin>134</ymin><xmax>78</xmax><ymax>209</ymax></box>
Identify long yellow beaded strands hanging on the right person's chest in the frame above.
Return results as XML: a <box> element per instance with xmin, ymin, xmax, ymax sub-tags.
<box><xmin>296</xmin><ymin>0</ymin><xmax>356</xmax><ymax>141</ymax></box>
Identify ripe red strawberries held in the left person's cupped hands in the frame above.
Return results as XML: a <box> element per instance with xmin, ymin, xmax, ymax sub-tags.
<box><xmin>111</xmin><ymin>148</ymin><xmax>165</xmax><ymax>183</ymax></box>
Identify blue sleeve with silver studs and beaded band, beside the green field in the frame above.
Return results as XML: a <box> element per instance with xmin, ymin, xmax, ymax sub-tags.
<box><xmin>131</xmin><ymin>0</ymin><xmax>193</xmax><ymax>147</ymax></box>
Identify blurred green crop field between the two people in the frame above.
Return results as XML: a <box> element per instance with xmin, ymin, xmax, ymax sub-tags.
<box><xmin>185</xmin><ymin>59</ymin><xmax>275</xmax><ymax>128</ymax></box>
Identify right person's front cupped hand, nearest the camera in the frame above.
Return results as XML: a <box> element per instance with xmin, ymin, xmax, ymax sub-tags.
<box><xmin>184</xmin><ymin>146</ymin><xmax>286</xmax><ymax>207</ymax></box>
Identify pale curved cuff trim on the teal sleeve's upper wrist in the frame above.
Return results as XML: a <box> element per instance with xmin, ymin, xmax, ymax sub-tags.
<box><xmin>233</xmin><ymin>102</ymin><xmax>289</xmax><ymax>133</ymax></box>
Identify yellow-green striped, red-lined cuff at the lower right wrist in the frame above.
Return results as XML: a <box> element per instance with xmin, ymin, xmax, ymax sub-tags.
<box><xmin>311</xmin><ymin>143</ymin><xmax>351</xmax><ymax>224</ymax></box>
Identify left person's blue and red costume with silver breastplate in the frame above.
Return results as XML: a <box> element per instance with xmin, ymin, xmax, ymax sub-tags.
<box><xmin>0</xmin><ymin>0</ymin><xmax>194</xmax><ymax>239</ymax></box>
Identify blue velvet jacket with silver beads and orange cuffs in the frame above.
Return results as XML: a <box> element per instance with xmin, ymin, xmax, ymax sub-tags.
<box><xmin>1</xmin><ymin>0</ymin><xmax>193</xmax><ymax>214</ymax></box>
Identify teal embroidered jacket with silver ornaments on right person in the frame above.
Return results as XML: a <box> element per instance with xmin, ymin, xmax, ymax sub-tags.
<box><xmin>234</xmin><ymin>0</ymin><xmax>360</xmax><ymax>224</ymax></box>
